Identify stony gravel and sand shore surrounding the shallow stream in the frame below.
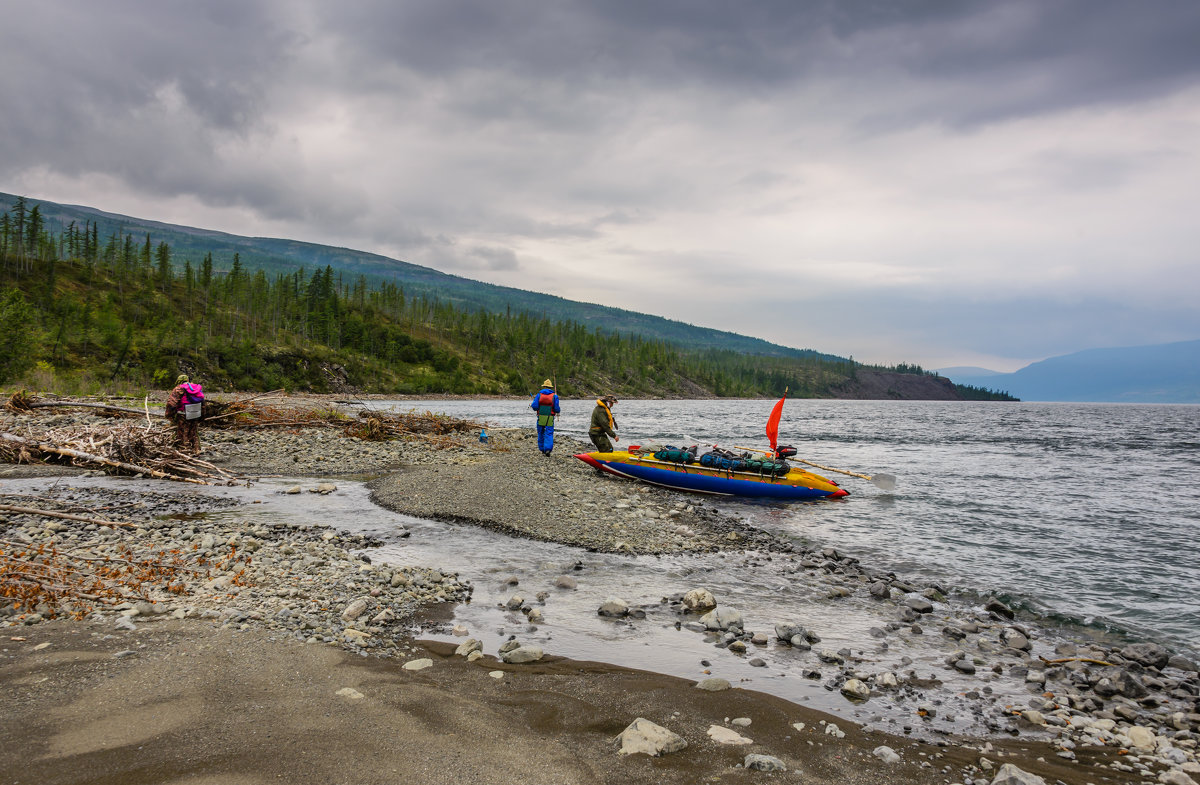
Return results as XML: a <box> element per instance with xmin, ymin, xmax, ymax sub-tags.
<box><xmin>0</xmin><ymin>402</ymin><xmax>1200</xmax><ymax>785</ymax></box>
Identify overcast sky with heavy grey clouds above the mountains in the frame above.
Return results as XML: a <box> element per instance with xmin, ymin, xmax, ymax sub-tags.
<box><xmin>0</xmin><ymin>0</ymin><xmax>1200</xmax><ymax>371</ymax></box>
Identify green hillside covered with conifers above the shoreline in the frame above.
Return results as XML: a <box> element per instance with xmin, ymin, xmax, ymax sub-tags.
<box><xmin>0</xmin><ymin>195</ymin><xmax>1012</xmax><ymax>397</ymax></box>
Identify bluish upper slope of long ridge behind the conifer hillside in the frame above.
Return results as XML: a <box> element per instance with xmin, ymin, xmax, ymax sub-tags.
<box><xmin>0</xmin><ymin>193</ymin><xmax>846</xmax><ymax>360</ymax></box>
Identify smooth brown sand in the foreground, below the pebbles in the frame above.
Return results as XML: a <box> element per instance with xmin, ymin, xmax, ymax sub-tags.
<box><xmin>0</xmin><ymin>619</ymin><xmax>1126</xmax><ymax>785</ymax></box>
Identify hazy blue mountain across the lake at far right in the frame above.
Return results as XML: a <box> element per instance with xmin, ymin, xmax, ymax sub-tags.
<box><xmin>938</xmin><ymin>340</ymin><xmax>1200</xmax><ymax>403</ymax></box>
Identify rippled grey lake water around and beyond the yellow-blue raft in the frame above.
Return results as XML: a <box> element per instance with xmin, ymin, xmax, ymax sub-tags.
<box><xmin>377</xmin><ymin>400</ymin><xmax>1200</xmax><ymax>653</ymax></box>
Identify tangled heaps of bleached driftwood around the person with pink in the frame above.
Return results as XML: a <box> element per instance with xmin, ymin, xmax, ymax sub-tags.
<box><xmin>0</xmin><ymin>391</ymin><xmax>496</xmax><ymax>485</ymax></box>
